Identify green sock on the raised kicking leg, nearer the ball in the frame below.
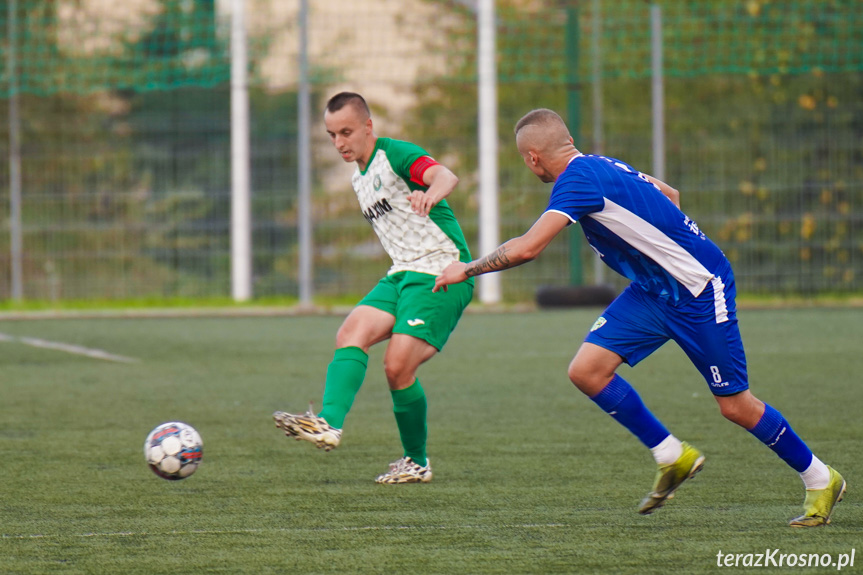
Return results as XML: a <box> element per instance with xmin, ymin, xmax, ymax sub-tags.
<box><xmin>318</xmin><ymin>347</ymin><xmax>369</xmax><ymax>429</ymax></box>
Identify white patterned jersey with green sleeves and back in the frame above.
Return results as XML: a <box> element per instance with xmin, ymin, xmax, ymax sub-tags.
<box><xmin>351</xmin><ymin>138</ymin><xmax>471</xmax><ymax>275</ymax></box>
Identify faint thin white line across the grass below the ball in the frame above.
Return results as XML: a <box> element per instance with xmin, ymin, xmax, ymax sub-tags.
<box><xmin>5</xmin><ymin>523</ymin><xmax>569</xmax><ymax>539</ymax></box>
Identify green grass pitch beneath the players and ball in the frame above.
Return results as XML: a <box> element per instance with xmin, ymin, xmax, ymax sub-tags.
<box><xmin>0</xmin><ymin>308</ymin><xmax>863</xmax><ymax>575</ymax></box>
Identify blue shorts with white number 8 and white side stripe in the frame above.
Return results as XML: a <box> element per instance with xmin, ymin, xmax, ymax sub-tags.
<box><xmin>585</xmin><ymin>269</ymin><xmax>749</xmax><ymax>395</ymax></box>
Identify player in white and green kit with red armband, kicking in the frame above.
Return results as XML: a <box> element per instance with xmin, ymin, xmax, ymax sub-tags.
<box><xmin>273</xmin><ymin>92</ymin><xmax>473</xmax><ymax>484</ymax></box>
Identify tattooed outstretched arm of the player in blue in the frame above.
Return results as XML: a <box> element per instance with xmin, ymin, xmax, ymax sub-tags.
<box><xmin>432</xmin><ymin>212</ymin><xmax>569</xmax><ymax>292</ymax></box>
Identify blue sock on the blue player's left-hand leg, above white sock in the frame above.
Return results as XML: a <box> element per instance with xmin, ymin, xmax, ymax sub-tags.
<box><xmin>590</xmin><ymin>374</ymin><xmax>671</xmax><ymax>448</ymax></box>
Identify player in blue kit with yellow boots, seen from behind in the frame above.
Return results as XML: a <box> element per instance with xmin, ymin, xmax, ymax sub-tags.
<box><xmin>434</xmin><ymin>109</ymin><xmax>845</xmax><ymax>527</ymax></box>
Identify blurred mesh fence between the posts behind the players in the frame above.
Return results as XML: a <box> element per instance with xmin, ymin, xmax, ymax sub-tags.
<box><xmin>0</xmin><ymin>0</ymin><xmax>863</xmax><ymax>301</ymax></box>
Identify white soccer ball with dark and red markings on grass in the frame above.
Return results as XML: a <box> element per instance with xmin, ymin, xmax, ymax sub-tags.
<box><xmin>144</xmin><ymin>421</ymin><xmax>204</xmax><ymax>480</ymax></box>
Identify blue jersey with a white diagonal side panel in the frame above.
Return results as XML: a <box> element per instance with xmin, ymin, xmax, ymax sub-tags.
<box><xmin>546</xmin><ymin>155</ymin><xmax>730</xmax><ymax>302</ymax></box>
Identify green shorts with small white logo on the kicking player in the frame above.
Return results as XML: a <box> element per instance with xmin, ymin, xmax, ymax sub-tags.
<box><xmin>358</xmin><ymin>272</ymin><xmax>473</xmax><ymax>351</ymax></box>
